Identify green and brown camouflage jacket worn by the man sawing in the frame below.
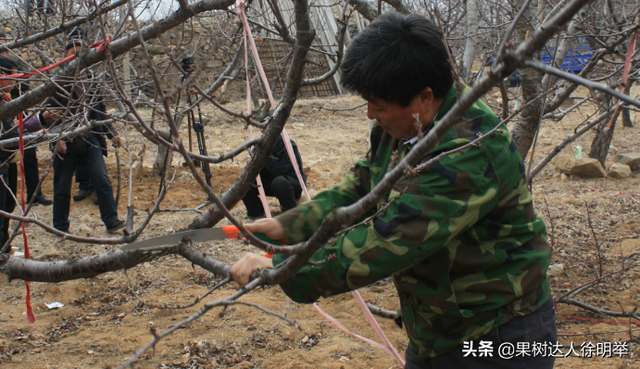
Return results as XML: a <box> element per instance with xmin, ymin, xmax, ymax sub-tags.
<box><xmin>273</xmin><ymin>88</ymin><xmax>550</xmax><ymax>357</ymax></box>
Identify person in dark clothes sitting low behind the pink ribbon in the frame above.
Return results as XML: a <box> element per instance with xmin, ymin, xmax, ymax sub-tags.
<box><xmin>242</xmin><ymin>137</ymin><xmax>307</xmax><ymax>218</ymax></box>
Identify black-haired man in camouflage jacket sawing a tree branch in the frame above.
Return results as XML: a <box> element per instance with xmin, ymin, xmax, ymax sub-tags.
<box><xmin>232</xmin><ymin>13</ymin><xmax>556</xmax><ymax>368</ymax></box>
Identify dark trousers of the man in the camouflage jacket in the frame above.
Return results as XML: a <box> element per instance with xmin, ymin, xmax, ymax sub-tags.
<box><xmin>405</xmin><ymin>298</ymin><xmax>566</xmax><ymax>369</ymax></box>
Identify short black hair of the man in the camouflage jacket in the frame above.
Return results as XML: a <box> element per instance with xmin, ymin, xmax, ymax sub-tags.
<box><xmin>342</xmin><ymin>12</ymin><xmax>453</xmax><ymax>107</ymax></box>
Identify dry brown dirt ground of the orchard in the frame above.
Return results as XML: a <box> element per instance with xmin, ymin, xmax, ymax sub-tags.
<box><xmin>0</xmin><ymin>92</ymin><xmax>640</xmax><ymax>369</ymax></box>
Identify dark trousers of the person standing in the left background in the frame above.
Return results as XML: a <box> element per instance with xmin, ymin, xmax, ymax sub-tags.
<box><xmin>53</xmin><ymin>135</ymin><xmax>118</xmax><ymax>233</ymax></box>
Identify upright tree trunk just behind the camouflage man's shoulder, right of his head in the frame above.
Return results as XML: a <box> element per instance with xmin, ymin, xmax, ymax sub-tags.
<box><xmin>512</xmin><ymin>0</ymin><xmax>542</xmax><ymax>159</ymax></box>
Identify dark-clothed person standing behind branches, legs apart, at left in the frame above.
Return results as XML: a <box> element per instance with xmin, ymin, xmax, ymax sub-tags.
<box><xmin>25</xmin><ymin>30</ymin><xmax>125</xmax><ymax>233</ymax></box>
